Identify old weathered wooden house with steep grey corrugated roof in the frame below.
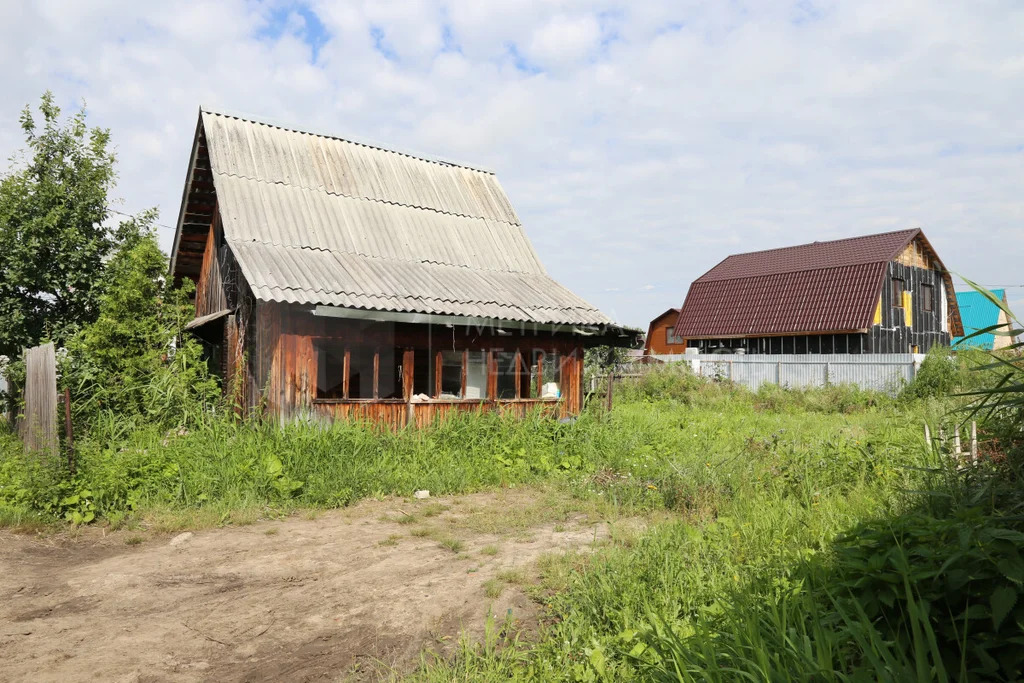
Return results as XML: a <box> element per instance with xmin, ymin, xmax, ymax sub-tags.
<box><xmin>171</xmin><ymin>110</ymin><xmax>637</xmax><ymax>425</ymax></box>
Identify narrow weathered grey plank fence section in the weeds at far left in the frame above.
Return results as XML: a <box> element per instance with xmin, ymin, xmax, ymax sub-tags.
<box><xmin>17</xmin><ymin>343</ymin><xmax>57</xmax><ymax>454</ymax></box>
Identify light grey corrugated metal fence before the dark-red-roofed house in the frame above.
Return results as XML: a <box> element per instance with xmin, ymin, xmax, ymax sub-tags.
<box><xmin>653</xmin><ymin>353</ymin><xmax>925</xmax><ymax>393</ymax></box>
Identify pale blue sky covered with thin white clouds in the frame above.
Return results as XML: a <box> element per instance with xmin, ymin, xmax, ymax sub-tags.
<box><xmin>0</xmin><ymin>0</ymin><xmax>1024</xmax><ymax>326</ymax></box>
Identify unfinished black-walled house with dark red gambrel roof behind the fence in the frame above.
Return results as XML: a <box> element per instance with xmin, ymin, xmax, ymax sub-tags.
<box><xmin>676</xmin><ymin>229</ymin><xmax>963</xmax><ymax>353</ymax></box>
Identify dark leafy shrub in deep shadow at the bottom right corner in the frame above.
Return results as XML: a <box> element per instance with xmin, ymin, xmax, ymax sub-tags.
<box><xmin>826</xmin><ymin>507</ymin><xmax>1024</xmax><ymax>681</ymax></box>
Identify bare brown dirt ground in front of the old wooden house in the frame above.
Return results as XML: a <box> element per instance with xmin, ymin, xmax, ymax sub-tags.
<box><xmin>0</xmin><ymin>492</ymin><xmax>607</xmax><ymax>681</ymax></box>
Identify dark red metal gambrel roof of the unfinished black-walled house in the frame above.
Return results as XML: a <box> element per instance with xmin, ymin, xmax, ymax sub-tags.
<box><xmin>676</xmin><ymin>228</ymin><xmax>959</xmax><ymax>338</ymax></box>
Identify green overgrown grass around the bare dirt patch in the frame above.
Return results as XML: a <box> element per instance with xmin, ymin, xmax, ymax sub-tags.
<box><xmin>0</xmin><ymin>372</ymin><xmax>1024</xmax><ymax>681</ymax></box>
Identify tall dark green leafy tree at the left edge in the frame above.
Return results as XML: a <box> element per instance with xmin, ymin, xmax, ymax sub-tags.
<box><xmin>0</xmin><ymin>91</ymin><xmax>118</xmax><ymax>358</ymax></box>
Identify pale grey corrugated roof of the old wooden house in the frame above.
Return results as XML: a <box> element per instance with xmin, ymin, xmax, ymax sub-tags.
<box><xmin>195</xmin><ymin>111</ymin><xmax>610</xmax><ymax>325</ymax></box>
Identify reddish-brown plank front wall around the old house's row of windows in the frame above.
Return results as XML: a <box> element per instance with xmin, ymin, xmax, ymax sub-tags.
<box><xmin>246</xmin><ymin>303</ymin><xmax>583</xmax><ymax>427</ymax></box>
